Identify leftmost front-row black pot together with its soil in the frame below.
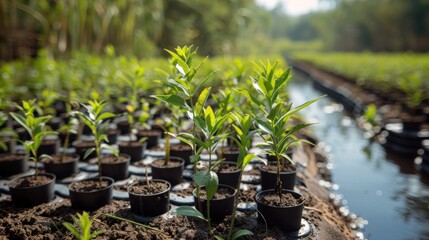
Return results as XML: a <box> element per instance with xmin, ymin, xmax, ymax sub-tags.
<box><xmin>9</xmin><ymin>173</ymin><xmax>55</xmax><ymax>207</ymax></box>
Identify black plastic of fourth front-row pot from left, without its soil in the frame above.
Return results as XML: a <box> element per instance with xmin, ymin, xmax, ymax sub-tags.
<box><xmin>192</xmin><ymin>184</ymin><xmax>237</xmax><ymax>222</ymax></box>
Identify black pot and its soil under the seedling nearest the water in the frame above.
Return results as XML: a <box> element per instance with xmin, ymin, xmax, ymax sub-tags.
<box><xmin>255</xmin><ymin>190</ymin><xmax>305</xmax><ymax>232</ymax></box>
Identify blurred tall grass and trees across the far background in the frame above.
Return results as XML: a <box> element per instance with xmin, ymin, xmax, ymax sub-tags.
<box><xmin>0</xmin><ymin>0</ymin><xmax>429</xmax><ymax>60</ymax></box>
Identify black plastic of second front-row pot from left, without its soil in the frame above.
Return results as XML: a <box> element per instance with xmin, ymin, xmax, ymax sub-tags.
<box><xmin>68</xmin><ymin>177</ymin><xmax>114</xmax><ymax>211</ymax></box>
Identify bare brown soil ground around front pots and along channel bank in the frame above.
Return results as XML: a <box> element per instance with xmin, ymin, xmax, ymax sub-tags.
<box><xmin>0</xmin><ymin>145</ymin><xmax>358</xmax><ymax>239</ymax></box>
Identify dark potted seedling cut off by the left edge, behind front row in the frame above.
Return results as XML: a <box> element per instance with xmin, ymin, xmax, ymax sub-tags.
<box><xmin>0</xmin><ymin>112</ymin><xmax>28</xmax><ymax>177</ymax></box>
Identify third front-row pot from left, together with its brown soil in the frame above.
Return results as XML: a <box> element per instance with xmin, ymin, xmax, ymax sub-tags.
<box><xmin>128</xmin><ymin>179</ymin><xmax>171</xmax><ymax>217</ymax></box>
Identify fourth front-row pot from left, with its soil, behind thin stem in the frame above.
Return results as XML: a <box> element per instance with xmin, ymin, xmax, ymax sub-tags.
<box><xmin>193</xmin><ymin>185</ymin><xmax>237</xmax><ymax>222</ymax></box>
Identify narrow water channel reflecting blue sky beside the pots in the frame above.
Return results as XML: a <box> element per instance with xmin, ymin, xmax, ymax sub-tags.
<box><xmin>289</xmin><ymin>72</ymin><xmax>429</xmax><ymax>239</ymax></box>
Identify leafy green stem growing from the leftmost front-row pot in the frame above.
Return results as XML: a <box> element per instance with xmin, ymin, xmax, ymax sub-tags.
<box><xmin>10</xmin><ymin>100</ymin><xmax>56</xmax><ymax>175</ymax></box>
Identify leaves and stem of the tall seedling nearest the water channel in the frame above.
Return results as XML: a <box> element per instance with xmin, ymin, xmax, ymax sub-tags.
<box><xmin>244</xmin><ymin>62</ymin><xmax>319</xmax><ymax>193</ymax></box>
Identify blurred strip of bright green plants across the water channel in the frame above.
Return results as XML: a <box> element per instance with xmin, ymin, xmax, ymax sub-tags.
<box><xmin>294</xmin><ymin>52</ymin><xmax>429</xmax><ymax>108</ymax></box>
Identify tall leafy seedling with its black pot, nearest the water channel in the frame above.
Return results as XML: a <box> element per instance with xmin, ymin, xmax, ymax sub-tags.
<box><xmin>244</xmin><ymin>62</ymin><xmax>317</xmax><ymax>232</ymax></box>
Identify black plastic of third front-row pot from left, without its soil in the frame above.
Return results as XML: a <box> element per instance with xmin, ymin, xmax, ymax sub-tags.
<box><xmin>128</xmin><ymin>179</ymin><xmax>171</xmax><ymax>217</ymax></box>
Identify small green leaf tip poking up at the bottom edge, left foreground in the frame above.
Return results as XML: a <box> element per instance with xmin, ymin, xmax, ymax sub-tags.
<box><xmin>63</xmin><ymin>211</ymin><xmax>105</xmax><ymax>240</ymax></box>
